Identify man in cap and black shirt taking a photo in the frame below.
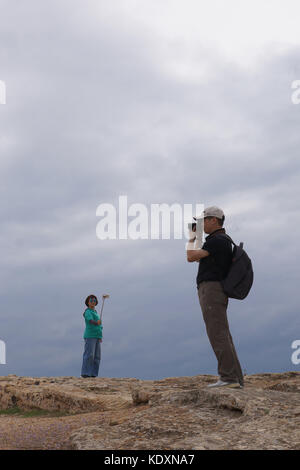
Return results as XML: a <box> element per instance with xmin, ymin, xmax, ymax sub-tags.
<box><xmin>187</xmin><ymin>206</ymin><xmax>244</xmax><ymax>387</ymax></box>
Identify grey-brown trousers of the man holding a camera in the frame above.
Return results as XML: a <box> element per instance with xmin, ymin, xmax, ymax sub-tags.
<box><xmin>198</xmin><ymin>281</ymin><xmax>244</xmax><ymax>385</ymax></box>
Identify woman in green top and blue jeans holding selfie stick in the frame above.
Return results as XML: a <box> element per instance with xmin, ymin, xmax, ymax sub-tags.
<box><xmin>81</xmin><ymin>295</ymin><xmax>102</xmax><ymax>378</ymax></box>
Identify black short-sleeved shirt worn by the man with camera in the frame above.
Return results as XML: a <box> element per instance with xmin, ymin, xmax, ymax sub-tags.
<box><xmin>197</xmin><ymin>228</ymin><xmax>232</xmax><ymax>287</ymax></box>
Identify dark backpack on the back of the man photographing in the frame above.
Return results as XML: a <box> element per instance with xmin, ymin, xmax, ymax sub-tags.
<box><xmin>218</xmin><ymin>233</ymin><xmax>253</xmax><ymax>300</ymax></box>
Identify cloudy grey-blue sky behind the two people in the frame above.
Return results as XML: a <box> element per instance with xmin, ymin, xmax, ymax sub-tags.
<box><xmin>0</xmin><ymin>0</ymin><xmax>300</xmax><ymax>379</ymax></box>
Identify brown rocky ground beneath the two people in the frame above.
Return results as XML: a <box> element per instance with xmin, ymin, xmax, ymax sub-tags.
<box><xmin>0</xmin><ymin>372</ymin><xmax>300</xmax><ymax>450</ymax></box>
